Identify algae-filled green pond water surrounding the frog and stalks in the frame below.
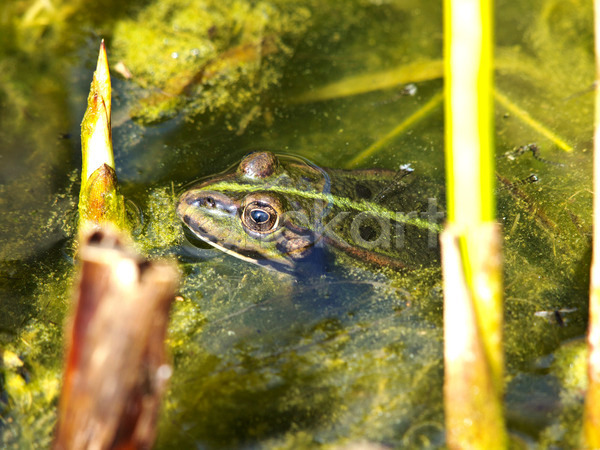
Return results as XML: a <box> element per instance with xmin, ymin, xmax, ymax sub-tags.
<box><xmin>0</xmin><ymin>0</ymin><xmax>594</xmax><ymax>448</ymax></box>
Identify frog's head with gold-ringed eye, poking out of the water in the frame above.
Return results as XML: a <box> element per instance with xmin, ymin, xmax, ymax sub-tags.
<box><xmin>177</xmin><ymin>152</ymin><xmax>323</xmax><ymax>271</ymax></box>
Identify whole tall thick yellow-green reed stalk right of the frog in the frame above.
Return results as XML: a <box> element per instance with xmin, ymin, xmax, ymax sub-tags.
<box><xmin>441</xmin><ymin>0</ymin><xmax>508</xmax><ymax>449</ymax></box>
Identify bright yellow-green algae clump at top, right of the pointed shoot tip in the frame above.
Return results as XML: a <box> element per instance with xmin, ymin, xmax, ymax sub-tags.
<box><xmin>113</xmin><ymin>0</ymin><xmax>311</xmax><ymax>125</ymax></box>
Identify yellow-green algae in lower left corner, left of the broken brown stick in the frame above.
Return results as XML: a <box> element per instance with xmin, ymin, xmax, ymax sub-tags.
<box><xmin>0</xmin><ymin>262</ymin><xmax>72</xmax><ymax>448</ymax></box>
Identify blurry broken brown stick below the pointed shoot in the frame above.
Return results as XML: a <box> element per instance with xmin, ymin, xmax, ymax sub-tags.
<box><xmin>54</xmin><ymin>231</ymin><xmax>177</xmax><ymax>449</ymax></box>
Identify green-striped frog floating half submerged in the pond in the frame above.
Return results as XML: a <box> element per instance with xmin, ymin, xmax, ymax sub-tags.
<box><xmin>177</xmin><ymin>151</ymin><xmax>443</xmax><ymax>273</ymax></box>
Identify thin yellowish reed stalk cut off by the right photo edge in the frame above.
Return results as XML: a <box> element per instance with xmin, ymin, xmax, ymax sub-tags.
<box><xmin>583</xmin><ymin>0</ymin><xmax>600</xmax><ymax>448</ymax></box>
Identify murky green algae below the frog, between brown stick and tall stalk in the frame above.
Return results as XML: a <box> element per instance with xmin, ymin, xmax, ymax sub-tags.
<box><xmin>159</xmin><ymin>257</ymin><xmax>442</xmax><ymax>448</ymax></box>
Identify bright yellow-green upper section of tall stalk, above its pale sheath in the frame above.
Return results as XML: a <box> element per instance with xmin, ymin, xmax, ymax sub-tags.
<box><xmin>444</xmin><ymin>0</ymin><xmax>495</xmax><ymax>226</ymax></box>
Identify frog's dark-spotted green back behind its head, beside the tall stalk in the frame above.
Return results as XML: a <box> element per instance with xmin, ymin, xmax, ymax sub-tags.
<box><xmin>326</xmin><ymin>167</ymin><xmax>443</xmax><ymax>269</ymax></box>
